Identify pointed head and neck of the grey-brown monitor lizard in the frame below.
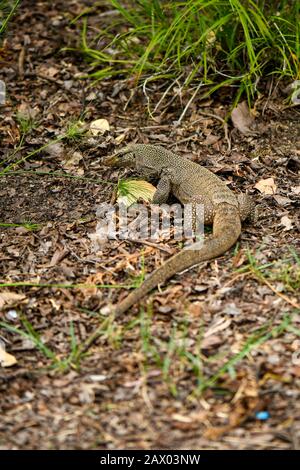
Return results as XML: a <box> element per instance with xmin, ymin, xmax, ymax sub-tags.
<box><xmin>103</xmin><ymin>144</ymin><xmax>164</xmax><ymax>178</ymax></box>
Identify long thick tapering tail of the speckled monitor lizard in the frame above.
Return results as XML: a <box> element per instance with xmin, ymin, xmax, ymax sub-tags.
<box><xmin>115</xmin><ymin>204</ymin><xmax>241</xmax><ymax>315</ymax></box>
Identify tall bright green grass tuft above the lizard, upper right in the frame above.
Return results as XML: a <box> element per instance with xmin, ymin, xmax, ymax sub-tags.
<box><xmin>75</xmin><ymin>0</ymin><xmax>300</xmax><ymax>106</ymax></box>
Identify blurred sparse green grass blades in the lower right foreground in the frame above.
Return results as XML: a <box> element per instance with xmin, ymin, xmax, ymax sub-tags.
<box><xmin>139</xmin><ymin>304</ymin><xmax>300</xmax><ymax>396</ymax></box>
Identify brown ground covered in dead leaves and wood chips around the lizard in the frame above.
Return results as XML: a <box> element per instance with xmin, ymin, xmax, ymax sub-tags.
<box><xmin>0</xmin><ymin>0</ymin><xmax>300</xmax><ymax>449</ymax></box>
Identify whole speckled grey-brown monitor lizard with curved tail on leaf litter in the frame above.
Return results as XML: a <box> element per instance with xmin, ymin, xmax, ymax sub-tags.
<box><xmin>104</xmin><ymin>144</ymin><xmax>254</xmax><ymax>315</ymax></box>
